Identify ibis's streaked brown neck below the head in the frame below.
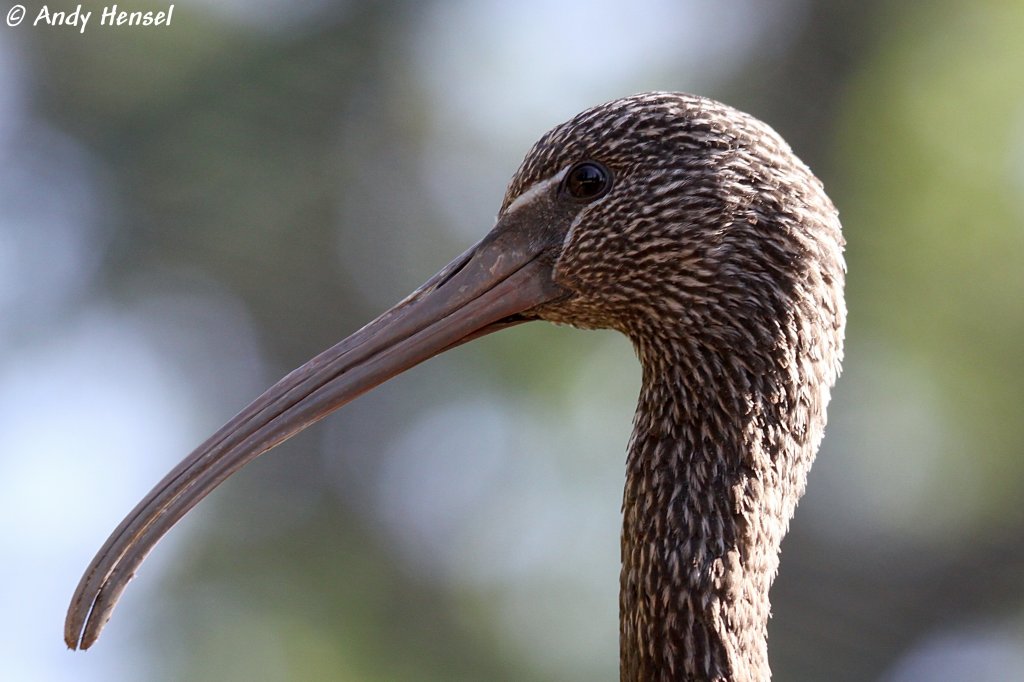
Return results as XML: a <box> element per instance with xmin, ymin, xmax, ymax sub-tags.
<box><xmin>620</xmin><ymin>339</ymin><xmax>816</xmax><ymax>682</ymax></box>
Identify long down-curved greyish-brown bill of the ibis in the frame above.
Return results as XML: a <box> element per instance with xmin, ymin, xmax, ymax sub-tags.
<box><xmin>65</xmin><ymin>218</ymin><xmax>566</xmax><ymax>649</ymax></box>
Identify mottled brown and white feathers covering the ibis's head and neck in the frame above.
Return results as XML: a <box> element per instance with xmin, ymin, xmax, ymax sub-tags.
<box><xmin>502</xmin><ymin>92</ymin><xmax>846</xmax><ymax>682</ymax></box>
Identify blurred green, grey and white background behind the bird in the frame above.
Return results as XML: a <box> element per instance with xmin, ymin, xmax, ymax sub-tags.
<box><xmin>0</xmin><ymin>0</ymin><xmax>1024</xmax><ymax>682</ymax></box>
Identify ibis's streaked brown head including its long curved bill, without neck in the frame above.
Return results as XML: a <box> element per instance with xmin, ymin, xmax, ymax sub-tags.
<box><xmin>66</xmin><ymin>93</ymin><xmax>843</xmax><ymax>648</ymax></box>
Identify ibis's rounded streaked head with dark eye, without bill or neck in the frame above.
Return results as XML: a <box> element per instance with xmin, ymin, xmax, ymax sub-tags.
<box><xmin>496</xmin><ymin>92</ymin><xmax>845</xmax><ymax>366</ymax></box>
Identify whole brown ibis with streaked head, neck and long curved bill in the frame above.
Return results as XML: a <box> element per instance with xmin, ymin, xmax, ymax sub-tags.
<box><xmin>65</xmin><ymin>92</ymin><xmax>846</xmax><ymax>682</ymax></box>
